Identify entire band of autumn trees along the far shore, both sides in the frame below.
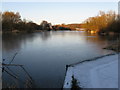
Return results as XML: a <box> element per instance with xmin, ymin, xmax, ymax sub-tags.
<box><xmin>1</xmin><ymin>11</ymin><xmax>120</xmax><ymax>35</ymax></box>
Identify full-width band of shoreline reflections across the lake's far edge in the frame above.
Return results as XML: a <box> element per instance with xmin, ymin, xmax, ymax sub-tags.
<box><xmin>2</xmin><ymin>31</ymin><xmax>117</xmax><ymax>52</ymax></box>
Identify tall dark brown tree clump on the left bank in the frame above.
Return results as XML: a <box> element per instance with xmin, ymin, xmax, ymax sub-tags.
<box><xmin>1</xmin><ymin>11</ymin><xmax>40</xmax><ymax>32</ymax></box>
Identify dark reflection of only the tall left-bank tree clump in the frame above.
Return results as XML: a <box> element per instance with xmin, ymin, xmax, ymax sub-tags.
<box><xmin>2</xmin><ymin>34</ymin><xmax>34</xmax><ymax>51</ymax></box>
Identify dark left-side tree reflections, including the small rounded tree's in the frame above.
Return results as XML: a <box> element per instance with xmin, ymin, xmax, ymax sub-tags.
<box><xmin>2</xmin><ymin>32</ymin><xmax>51</xmax><ymax>51</ymax></box>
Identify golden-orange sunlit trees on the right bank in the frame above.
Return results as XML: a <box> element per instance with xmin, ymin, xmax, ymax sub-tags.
<box><xmin>82</xmin><ymin>11</ymin><xmax>120</xmax><ymax>34</ymax></box>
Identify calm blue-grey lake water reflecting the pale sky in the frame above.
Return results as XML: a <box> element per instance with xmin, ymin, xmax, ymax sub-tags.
<box><xmin>3</xmin><ymin>31</ymin><xmax>112</xmax><ymax>88</ymax></box>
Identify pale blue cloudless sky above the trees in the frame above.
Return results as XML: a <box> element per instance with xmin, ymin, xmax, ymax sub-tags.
<box><xmin>2</xmin><ymin>2</ymin><xmax>118</xmax><ymax>24</ymax></box>
